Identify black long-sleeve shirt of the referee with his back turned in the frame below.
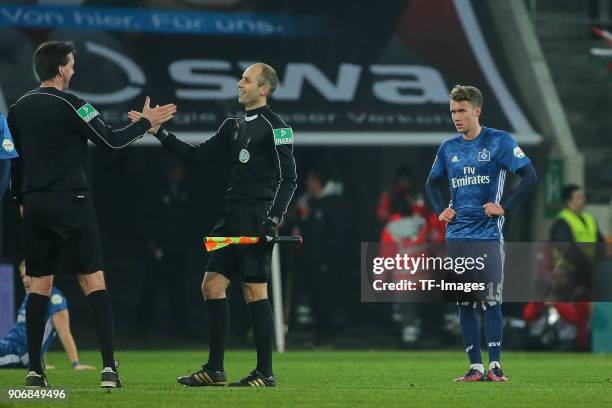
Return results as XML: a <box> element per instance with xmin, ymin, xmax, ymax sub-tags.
<box><xmin>7</xmin><ymin>87</ymin><xmax>151</xmax><ymax>202</ymax></box>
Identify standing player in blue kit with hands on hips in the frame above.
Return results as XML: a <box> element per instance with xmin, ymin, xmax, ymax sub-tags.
<box><xmin>426</xmin><ymin>85</ymin><xmax>537</xmax><ymax>382</ymax></box>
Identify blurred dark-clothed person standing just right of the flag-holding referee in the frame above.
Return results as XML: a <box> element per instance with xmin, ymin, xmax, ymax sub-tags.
<box><xmin>294</xmin><ymin>169</ymin><xmax>346</xmax><ymax>346</ymax></box>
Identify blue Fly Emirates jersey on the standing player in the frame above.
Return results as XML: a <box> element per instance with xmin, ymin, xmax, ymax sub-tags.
<box><xmin>430</xmin><ymin>126</ymin><xmax>531</xmax><ymax>241</ymax></box>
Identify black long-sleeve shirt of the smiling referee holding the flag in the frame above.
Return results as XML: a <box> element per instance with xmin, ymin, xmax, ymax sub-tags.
<box><xmin>157</xmin><ymin>105</ymin><xmax>297</xmax><ymax>218</ymax></box>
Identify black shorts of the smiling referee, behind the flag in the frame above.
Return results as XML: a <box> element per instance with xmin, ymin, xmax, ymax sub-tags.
<box><xmin>206</xmin><ymin>201</ymin><xmax>273</xmax><ymax>283</ymax></box>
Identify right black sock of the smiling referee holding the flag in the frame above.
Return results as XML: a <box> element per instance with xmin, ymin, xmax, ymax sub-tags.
<box><xmin>249</xmin><ymin>299</ymin><xmax>274</xmax><ymax>377</ymax></box>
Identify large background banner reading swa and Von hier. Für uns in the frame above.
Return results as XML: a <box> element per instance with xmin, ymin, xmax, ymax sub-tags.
<box><xmin>0</xmin><ymin>0</ymin><xmax>541</xmax><ymax>145</ymax></box>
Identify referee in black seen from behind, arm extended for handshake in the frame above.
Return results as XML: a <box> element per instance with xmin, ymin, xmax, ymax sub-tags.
<box><xmin>8</xmin><ymin>41</ymin><xmax>176</xmax><ymax>388</ymax></box>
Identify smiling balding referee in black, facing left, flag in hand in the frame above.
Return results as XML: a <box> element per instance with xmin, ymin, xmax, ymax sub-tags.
<box><xmin>130</xmin><ymin>63</ymin><xmax>296</xmax><ymax>387</ymax></box>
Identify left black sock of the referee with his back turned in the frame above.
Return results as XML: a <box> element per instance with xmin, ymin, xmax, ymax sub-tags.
<box><xmin>26</xmin><ymin>293</ymin><xmax>49</xmax><ymax>374</ymax></box>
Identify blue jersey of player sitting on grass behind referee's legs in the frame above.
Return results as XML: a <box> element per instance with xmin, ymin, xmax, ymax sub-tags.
<box><xmin>2</xmin><ymin>287</ymin><xmax>68</xmax><ymax>355</ymax></box>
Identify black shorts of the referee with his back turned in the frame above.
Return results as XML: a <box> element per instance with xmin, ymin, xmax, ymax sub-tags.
<box><xmin>23</xmin><ymin>191</ymin><xmax>102</xmax><ymax>277</ymax></box>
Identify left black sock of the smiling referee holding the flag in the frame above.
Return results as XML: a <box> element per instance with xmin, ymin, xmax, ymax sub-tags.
<box><xmin>206</xmin><ymin>298</ymin><xmax>230</xmax><ymax>371</ymax></box>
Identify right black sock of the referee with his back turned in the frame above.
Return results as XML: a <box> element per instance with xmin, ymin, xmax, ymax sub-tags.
<box><xmin>87</xmin><ymin>289</ymin><xmax>115</xmax><ymax>370</ymax></box>
